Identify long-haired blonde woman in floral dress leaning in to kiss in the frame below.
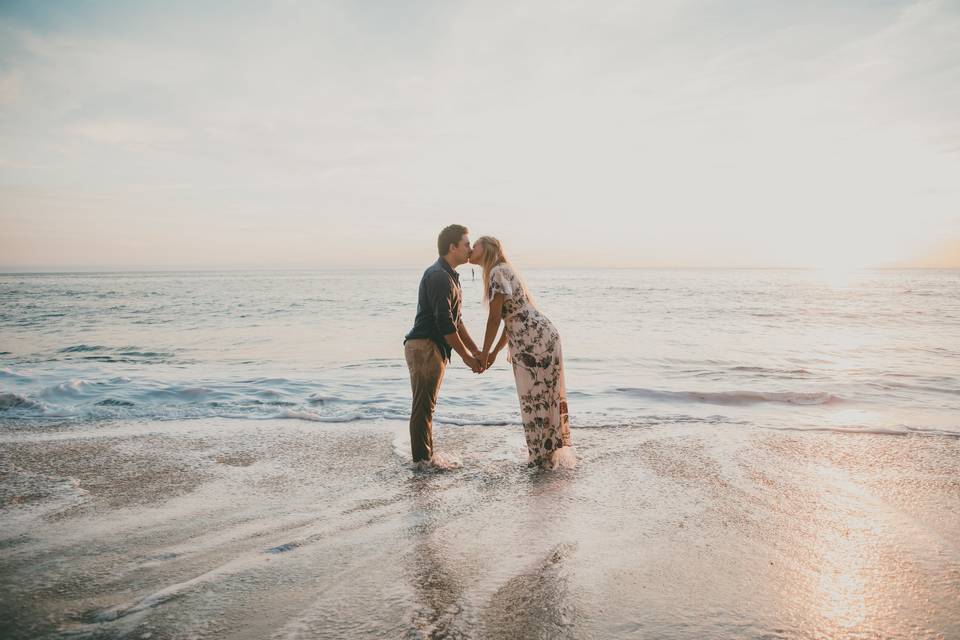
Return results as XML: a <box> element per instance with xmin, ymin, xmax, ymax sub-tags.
<box><xmin>470</xmin><ymin>236</ymin><xmax>575</xmax><ymax>469</ymax></box>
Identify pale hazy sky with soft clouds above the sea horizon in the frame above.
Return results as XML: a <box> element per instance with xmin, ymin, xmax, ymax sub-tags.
<box><xmin>0</xmin><ymin>0</ymin><xmax>960</xmax><ymax>271</ymax></box>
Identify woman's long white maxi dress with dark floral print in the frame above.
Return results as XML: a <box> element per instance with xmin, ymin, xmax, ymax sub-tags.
<box><xmin>488</xmin><ymin>263</ymin><xmax>570</xmax><ymax>467</ymax></box>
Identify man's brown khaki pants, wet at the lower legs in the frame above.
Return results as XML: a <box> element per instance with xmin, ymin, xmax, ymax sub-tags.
<box><xmin>404</xmin><ymin>338</ymin><xmax>447</xmax><ymax>462</ymax></box>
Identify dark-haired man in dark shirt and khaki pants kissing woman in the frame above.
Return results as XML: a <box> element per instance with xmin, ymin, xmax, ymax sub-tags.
<box><xmin>403</xmin><ymin>224</ymin><xmax>482</xmax><ymax>462</ymax></box>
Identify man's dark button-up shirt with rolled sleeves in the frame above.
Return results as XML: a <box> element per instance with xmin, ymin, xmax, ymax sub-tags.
<box><xmin>403</xmin><ymin>258</ymin><xmax>463</xmax><ymax>360</ymax></box>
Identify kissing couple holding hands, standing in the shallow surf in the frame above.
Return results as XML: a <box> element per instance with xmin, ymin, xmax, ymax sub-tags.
<box><xmin>404</xmin><ymin>224</ymin><xmax>574</xmax><ymax>469</ymax></box>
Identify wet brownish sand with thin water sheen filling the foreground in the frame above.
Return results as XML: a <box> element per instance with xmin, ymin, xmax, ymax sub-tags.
<box><xmin>0</xmin><ymin>419</ymin><xmax>960</xmax><ymax>639</ymax></box>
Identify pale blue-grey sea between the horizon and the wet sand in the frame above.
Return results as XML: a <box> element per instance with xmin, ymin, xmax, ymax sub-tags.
<box><xmin>0</xmin><ymin>267</ymin><xmax>960</xmax><ymax>434</ymax></box>
